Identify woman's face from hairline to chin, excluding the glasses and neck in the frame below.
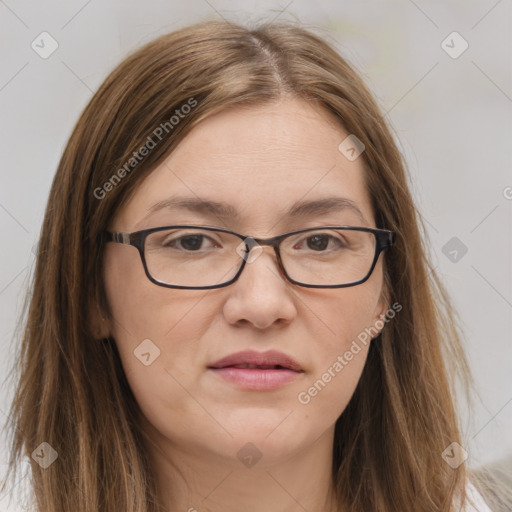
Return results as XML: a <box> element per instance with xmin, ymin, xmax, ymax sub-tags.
<box><xmin>104</xmin><ymin>99</ymin><xmax>386</xmax><ymax>472</ymax></box>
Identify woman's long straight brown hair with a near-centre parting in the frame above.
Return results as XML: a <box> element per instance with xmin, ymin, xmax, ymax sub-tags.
<box><xmin>2</xmin><ymin>21</ymin><xmax>502</xmax><ymax>512</ymax></box>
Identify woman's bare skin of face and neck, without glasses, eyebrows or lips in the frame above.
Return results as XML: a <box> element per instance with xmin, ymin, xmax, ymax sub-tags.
<box><xmin>99</xmin><ymin>98</ymin><xmax>387</xmax><ymax>512</ymax></box>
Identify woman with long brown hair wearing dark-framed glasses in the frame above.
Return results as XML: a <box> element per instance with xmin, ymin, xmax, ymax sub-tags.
<box><xmin>1</xmin><ymin>21</ymin><xmax>504</xmax><ymax>512</ymax></box>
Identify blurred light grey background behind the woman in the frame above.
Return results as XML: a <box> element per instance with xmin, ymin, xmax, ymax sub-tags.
<box><xmin>0</xmin><ymin>0</ymin><xmax>512</xmax><ymax>510</ymax></box>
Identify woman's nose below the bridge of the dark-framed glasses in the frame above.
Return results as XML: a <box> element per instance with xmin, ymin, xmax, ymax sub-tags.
<box><xmin>224</xmin><ymin>242</ymin><xmax>297</xmax><ymax>329</ymax></box>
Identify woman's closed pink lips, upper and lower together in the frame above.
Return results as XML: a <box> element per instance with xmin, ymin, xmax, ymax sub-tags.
<box><xmin>208</xmin><ymin>350</ymin><xmax>304</xmax><ymax>391</ymax></box>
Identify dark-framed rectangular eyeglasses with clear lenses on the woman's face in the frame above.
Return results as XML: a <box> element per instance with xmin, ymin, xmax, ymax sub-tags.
<box><xmin>105</xmin><ymin>225</ymin><xmax>395</xmax><ymax>290</ymax></box>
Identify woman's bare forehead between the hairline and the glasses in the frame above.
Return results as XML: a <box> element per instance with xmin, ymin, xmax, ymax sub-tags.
<box><xmin>116</xmin><ymin>99</ymin><xmax>373</xmax><ymax>232</ymax></box>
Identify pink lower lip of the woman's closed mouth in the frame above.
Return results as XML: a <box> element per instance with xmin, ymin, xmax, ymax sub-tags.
<box><xmin>210</xmin><ymin>367</ymin><xmax>302</xmax><ymax>391</ymax></box>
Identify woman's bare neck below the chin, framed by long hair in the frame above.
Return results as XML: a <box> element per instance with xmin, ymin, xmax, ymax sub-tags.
<box><xmin>148</xmin><ymin>429</ymin><xmax>339</xmax><ymax>512</ymax></box>
